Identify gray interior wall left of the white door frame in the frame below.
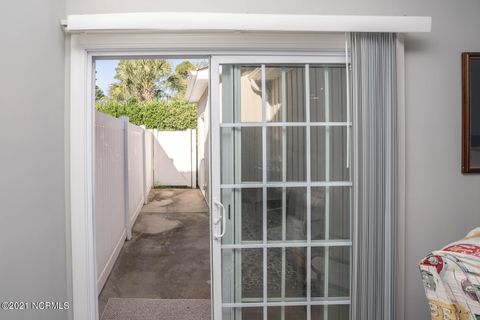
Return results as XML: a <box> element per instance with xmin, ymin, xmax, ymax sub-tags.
<box><xmin>0</xmin><ymin>0</ymin><xmax>68</xmax><ymax>320</ymax></box>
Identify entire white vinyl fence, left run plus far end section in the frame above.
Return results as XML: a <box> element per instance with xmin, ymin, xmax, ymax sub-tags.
<box><xmin>94</xmin><ymin>112</ymin><xmax>196</xmax><ymax>293</ymax></box>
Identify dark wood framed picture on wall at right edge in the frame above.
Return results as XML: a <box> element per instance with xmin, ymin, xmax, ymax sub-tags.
<box><xmin>462</xmin><ymin>52</ymin><xmax>480</xmax><ymax>173</ymax></box>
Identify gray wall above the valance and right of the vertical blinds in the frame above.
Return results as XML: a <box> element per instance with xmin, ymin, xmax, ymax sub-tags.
<box><xmin>59</xmin><ymin>0</ymin><xmax>480</xmax><ymax>319</ymax></box>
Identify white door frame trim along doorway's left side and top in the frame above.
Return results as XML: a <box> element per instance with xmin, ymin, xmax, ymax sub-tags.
<box><xmin>66</xmin><ymin>32</ymin><xmax>402</xmax><ymax>320</ymax></box>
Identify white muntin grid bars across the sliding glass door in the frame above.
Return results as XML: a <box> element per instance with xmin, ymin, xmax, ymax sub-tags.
<box><xmin>219</xmin><ymin>63</ymin><xmax>353</xmax><ymax>320</ymax></box>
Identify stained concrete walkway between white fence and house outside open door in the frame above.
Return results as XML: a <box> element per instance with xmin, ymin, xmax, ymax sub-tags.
<box><xmin>99</xmin><ymin>189</ymin><xmax>210</xmax><ymax>314</ymax></box>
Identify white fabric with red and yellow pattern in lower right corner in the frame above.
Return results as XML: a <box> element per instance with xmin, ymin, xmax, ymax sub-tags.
<box><xmin>420</xmin><ymin>228</ymin><xmax>480</xmax><ymax>320</ymax></box>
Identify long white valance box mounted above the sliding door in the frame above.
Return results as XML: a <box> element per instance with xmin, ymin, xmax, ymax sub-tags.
<box><xmin>62</xmin><ymin>12</ymin><xmax>432</xmax><ymax>33</ymax></box>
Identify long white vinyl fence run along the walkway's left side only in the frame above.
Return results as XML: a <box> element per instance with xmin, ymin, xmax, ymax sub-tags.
<box><xmin>95</xmin><ymin>112</ymin><xmax>153</xmax><ymax>292</ymax></box>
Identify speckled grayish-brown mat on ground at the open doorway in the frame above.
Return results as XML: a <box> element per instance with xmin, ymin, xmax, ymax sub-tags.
<box><xmin>101</xmin><ymin>298</ymin><xmax>210</xmax><ymax>320</ymax></box>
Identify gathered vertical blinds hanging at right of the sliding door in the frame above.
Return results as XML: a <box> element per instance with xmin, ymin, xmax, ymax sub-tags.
<box><xmin>351</xmin><ymin>33</ymin><xmax>398</xmax><ymax>320</ymax></box>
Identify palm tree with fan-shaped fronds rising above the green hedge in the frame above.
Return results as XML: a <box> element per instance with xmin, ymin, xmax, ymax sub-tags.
<box><xmin>110</xmin><ymin>59</ymin><xmax>172</xmax><ymax>101</ymax></box>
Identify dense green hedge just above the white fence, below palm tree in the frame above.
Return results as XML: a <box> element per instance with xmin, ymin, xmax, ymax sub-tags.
<box><xmin>96</xmin><ymin>98</ymin><xmax>197</xmax><ymax>130</ymax></box>
